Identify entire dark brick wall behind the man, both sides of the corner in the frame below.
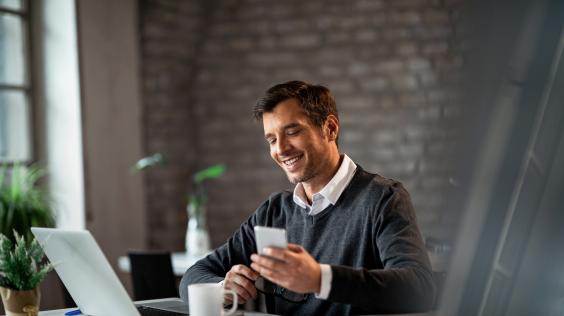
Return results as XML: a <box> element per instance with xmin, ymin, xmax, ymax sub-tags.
<box><xmin>140</xmin><ymin>0</ymin><xmax>461</xmax><ymax>249</ymax></box>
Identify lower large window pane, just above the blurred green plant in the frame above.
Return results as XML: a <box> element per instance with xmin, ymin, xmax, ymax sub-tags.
<box><xmin>0</xmin><ymin>91</ymin><xmax>31</xmax><ymax>161</ymax></box>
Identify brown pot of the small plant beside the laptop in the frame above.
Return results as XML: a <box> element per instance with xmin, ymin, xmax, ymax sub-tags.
<box><xmin>0</xmin><ymin>286</ymin><xmax>41</xmax><ymax>316</ymax></box>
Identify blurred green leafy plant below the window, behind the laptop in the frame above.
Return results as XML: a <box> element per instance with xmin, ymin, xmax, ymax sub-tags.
<box><xmin>0</xmin><ymin>164</ymin><xmax>55</xmax><ymax>240</ymax></box>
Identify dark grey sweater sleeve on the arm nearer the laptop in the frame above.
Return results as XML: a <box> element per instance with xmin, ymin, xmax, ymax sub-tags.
<box><xmin>179</xmin><ymin>202</ymin><xmax>267</xmax><ymax>302</ymax></box>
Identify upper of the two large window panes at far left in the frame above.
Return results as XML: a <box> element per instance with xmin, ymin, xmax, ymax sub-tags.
<box><xmin>0</xmin><ymin>12</ymin><xmax>25</xmax><ymax>86</ymax></box>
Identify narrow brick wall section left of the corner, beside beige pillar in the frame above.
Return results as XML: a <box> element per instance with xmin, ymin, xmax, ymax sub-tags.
<box><xmin>139</xmin><ymin>1</ymin><xmax>204</xmax><ymax>249</ymax></box>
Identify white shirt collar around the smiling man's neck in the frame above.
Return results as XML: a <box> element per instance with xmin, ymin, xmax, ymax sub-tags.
<box><xmin>293</xmin><ymin>154</ymin><xmax>356</xmax><ymax>208</ymax></box>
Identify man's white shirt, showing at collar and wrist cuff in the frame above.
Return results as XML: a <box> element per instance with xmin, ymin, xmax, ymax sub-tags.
<box><xmin>293</xmin><ymin>154</ymin><xmax>356</xmax><ymax>299</ymax></box>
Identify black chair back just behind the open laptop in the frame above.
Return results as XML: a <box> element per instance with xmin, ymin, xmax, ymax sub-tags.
<box><xmin>128</xmin><ymin>251</ymin><xmax>178</xmax><ymax>301</ymax></box>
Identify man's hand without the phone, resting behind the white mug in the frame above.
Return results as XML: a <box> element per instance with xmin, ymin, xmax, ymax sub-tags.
<box><xmin>223</xmin><ymin>264</ymin><xmax>259</xmax><ymax>304</ymax></box>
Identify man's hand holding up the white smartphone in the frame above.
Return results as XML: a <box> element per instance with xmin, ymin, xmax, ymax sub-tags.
<box><xmin>251</xmin><ymin>244</ymin><xmax>321</xmax><ymax>293</ymax></box>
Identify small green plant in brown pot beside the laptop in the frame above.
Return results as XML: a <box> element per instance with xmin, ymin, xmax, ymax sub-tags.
<box><xmin>0</xmin><ymin>231</ymin><xmax>53</xmax><ymax>316</ymax></box>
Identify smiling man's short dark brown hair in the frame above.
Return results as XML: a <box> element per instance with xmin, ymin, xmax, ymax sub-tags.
<box><xmin>253</xmin><ymin>81</ymin><xmax>339</xmax><ymax>127</ymax></box>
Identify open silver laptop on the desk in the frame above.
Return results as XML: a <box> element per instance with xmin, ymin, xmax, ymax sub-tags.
<box><xmin>31</xmin><ymin>227</ymin><xmax>188</xmax><ymax>316</ymax></box>
